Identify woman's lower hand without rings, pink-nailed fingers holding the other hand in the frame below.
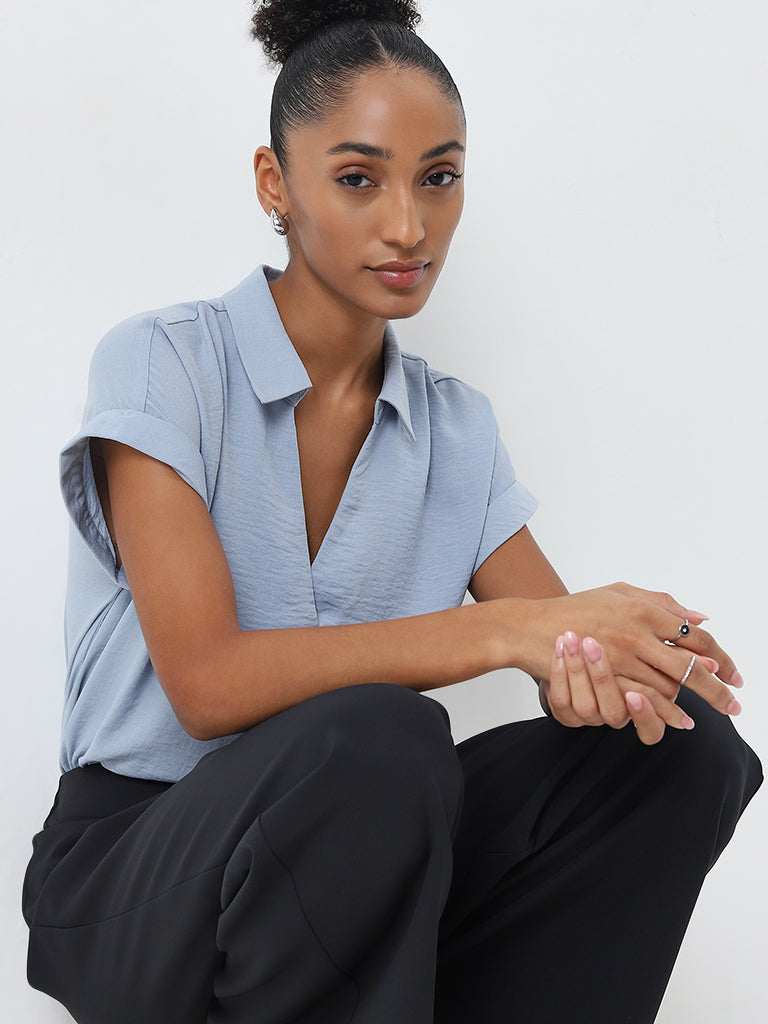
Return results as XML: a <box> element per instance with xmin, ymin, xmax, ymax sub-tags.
<box><xmin>539</xmin><ymin>632</ymin><xmax>694</xmax><ymax>744</ymax></box>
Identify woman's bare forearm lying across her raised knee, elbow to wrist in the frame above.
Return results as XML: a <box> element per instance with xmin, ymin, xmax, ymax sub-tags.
<box><xmin>169</xmin><ymin>600</ymin><xmax>531</xmax><ymax>739</ymax></box>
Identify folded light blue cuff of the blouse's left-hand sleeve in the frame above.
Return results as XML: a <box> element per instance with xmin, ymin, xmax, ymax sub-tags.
<box><xmin>59</xmin><ymin>410</ymin><xmax>209</xmax><ymax>586</ymax></box>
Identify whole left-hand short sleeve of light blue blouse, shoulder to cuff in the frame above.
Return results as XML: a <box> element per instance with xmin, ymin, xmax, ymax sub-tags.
<box><xmin>59</xmin><ymin>316</ymin><xmax>209</xmax><ymax>586</ymax></box>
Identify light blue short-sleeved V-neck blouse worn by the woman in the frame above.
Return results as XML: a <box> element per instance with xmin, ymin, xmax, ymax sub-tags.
<box><xmin>61</xmin><ymin>267</ymin><xmax>536</xmax><ymax>780</ymax></box>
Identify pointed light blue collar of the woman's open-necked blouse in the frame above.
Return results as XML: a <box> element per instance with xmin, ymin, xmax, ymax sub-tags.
<box><xmin>223</xmin><ymin>266</ymin><xmax>415</xmax><ymax>437</ymax></box>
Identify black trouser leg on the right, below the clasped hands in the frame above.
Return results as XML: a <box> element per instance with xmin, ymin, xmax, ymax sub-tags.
<box><xmin>435</xmin><ymin>693</ymin><xmax>762</xmax><ymax>1024</ymax></box>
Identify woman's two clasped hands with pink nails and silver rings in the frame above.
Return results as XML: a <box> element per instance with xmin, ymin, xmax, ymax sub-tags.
<box><xmin>539</xmin><ymin>584</ymin><xmax>743</xmax><ymax>743</ymax></box>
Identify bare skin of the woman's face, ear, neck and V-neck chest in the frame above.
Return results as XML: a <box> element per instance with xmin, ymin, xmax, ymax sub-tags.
<box><xmin>254</xmin><ymin>71</ymin><xmax>465</xmax><ymax>558</ymax></box>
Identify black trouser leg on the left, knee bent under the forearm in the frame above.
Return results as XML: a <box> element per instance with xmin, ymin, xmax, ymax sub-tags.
<box><xmin>25</xmin><ymin>684</ymin><xmax>462</xmax><ymax>1024</ymax></box>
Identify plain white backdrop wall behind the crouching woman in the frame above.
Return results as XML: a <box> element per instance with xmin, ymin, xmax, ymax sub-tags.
<box><xmin>0</xmin><ymin>0</ymin><xmax>768</xmax><ymax>1024</ymax></box>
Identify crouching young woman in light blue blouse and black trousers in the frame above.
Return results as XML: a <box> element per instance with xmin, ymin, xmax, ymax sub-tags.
<box><xmin>25</xmin><ymin>0</ymin><xmax>761</xmax><ymax>1024</ymax></box>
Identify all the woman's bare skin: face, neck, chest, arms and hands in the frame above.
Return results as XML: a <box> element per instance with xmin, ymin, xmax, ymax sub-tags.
<box><xmin>92</xmin><ymin>69</ymin><xmax>740</xmax><ymax>743</ymax></box>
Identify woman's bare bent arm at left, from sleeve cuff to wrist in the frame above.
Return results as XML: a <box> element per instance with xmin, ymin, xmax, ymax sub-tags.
<box><xmin>99</xmin><ymin>441</ymin><xmax>741</xmax><ymax>739</ymax></box>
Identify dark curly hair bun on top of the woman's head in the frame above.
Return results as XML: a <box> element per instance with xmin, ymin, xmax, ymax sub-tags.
<box><xmin>251</xmin><ymin>0</ymin><xmax>421</xmax><ymax>65</ymax></box>
